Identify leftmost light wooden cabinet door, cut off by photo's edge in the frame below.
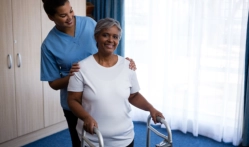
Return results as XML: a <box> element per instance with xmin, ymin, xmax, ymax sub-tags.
<box><xmin>0</xmin><ymin>0</ymin><xmax>17</xmax><ymax>142</ymax></box>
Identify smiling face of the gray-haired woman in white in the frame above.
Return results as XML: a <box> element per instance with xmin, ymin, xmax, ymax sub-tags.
<box><xmin>95</xmin><ymin>25</ymin><xmax>120</xmax><ymax>54</ymax></box>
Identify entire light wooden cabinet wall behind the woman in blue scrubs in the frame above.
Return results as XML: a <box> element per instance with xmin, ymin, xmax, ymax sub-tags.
<box><xmin>0</xmin><ymin>0</ymin><xmax>86</xmax><ymax>147</ymax></box>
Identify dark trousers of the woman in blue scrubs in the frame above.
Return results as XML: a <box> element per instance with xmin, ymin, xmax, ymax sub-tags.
<box><xmin>63</xmin><ymin>109</ymin><xmax>81</xmax><ymax>147</ymax></box>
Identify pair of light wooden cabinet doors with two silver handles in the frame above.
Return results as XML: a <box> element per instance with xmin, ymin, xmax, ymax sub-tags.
<box><xmin>0</xmin><ymin>0</ymin><xmax>44</xmax><ymax>142</ymax></box>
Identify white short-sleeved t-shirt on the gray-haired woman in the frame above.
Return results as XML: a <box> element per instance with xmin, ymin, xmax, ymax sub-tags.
<box><xmin>68</xmin><ymin>56</ymin><xmax>140</xmax><ymax>147</ymax></box>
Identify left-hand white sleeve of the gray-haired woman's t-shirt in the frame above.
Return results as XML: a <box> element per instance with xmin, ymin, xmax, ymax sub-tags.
<box><xmin>67</xmin><ymin>72</ymin><xmax>84</xmax><ymax>92</ymax></box>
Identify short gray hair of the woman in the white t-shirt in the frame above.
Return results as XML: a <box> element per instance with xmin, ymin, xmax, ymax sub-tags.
<box><xmin>94</xmin><ymin>18</ymin><xmax>122</xmax><ymax>40</ymax></box>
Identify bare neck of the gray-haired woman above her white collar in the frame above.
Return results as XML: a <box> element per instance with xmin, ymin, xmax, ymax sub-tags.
<box><xmin>93</xmin><ymin>53</ymin><xmax>118</xmax><ymax>67</ymax></box>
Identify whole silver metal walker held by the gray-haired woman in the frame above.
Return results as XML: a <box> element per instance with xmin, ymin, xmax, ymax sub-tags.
<box><xmin>81</xmin><ymin>115</ymin><xmax>173</xmax><ymax>147</ymax></box>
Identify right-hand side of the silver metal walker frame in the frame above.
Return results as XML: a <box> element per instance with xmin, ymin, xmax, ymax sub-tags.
<box><xmin>146</xmin><ymin>115</ymin><xmax>173</xmax><ymax>147</ymax></box>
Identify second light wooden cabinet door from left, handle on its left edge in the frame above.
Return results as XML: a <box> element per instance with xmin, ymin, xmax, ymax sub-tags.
<box><xmin>12</xmin><ymin>0</ymin><xmax>44</xmax><ymax>136</ymax></box>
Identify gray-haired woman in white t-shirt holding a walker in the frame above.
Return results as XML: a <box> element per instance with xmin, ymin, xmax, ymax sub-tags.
<box><xmin>68</xmin><ymin>18</ymin><xmax>164</xmax><ymax>147</ymax></box>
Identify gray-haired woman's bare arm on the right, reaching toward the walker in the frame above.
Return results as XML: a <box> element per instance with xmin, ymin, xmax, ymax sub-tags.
<box><xmin>129</xmin><ymin>92</ymin><xmax>164</xmax><ymax>123</ymax></box>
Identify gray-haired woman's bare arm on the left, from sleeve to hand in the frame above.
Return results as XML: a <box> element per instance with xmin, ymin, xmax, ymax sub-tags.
<box><xmin>67</xmin><ymin>91</ymin><xmax>98</xmax><ymax>134</ymax></box>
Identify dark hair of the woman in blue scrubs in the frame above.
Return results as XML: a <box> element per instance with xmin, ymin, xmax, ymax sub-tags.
<box><xmin>42</xmin><ymin>0</ymin><xmax>68</xmax><ymax>16</ymax></box>
